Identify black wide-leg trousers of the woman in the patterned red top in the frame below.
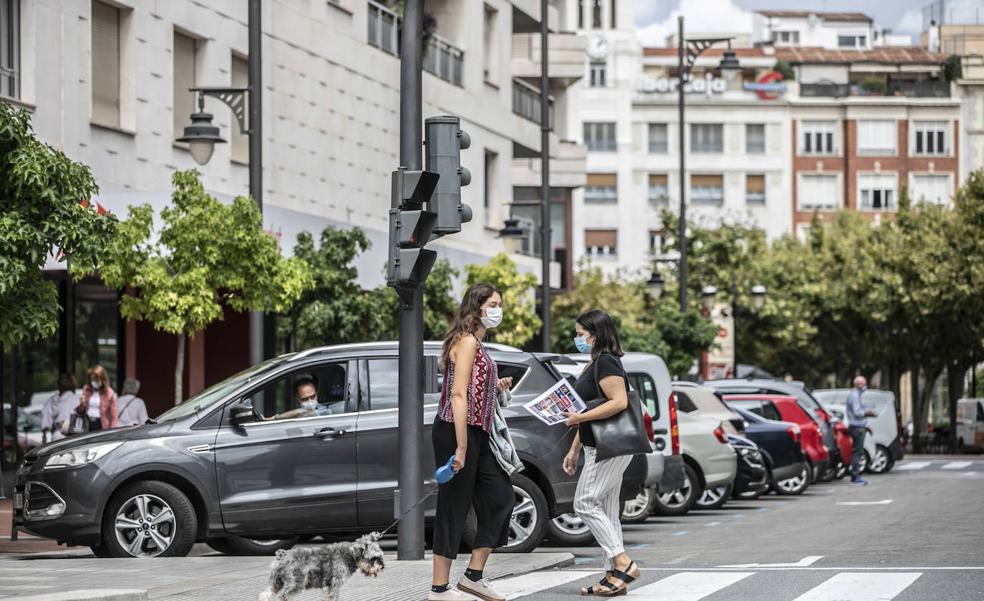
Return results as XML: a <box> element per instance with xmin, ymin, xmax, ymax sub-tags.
<box><xmin>432</xmin><ymin>417</ymin><xmax>516</xmax><ymax>559</ymax></box>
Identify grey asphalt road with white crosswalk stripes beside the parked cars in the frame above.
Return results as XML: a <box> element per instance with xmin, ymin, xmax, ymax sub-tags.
<box><xmin>512</xmin><ymin>457</ymin><xmax>984</xmax><ymax>601</ymax></box>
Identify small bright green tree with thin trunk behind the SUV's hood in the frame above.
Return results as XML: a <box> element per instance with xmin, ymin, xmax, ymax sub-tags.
<box><xmin>101</xmin><ymin>171</ymin><xmax>313</xmax><ymax>404</ymax></box>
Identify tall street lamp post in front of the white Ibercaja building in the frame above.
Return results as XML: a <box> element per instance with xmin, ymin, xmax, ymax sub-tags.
<box><xmin>677</xmin><ymin>15</ymin><xmax>738</xmax><ymax>313</ymax></box>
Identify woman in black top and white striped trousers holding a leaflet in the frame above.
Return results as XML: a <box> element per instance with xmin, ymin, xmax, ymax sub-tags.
<box><xmin>564</xmin><ymin>309</ymin><xmax>641</xmax><ymax>597</ymax></box>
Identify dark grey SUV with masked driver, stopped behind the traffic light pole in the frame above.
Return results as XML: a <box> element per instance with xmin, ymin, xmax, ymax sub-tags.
<box><xmin>14</xmin><ymin>342</ymin><xmax>645</xmax><ymax>557</ymax></box>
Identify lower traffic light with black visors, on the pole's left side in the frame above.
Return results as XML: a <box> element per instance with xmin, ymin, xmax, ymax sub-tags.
<box><xmin>386</xmin><ymin>169</ymin><xmax>438</xmax><ymax>287</ymax></box>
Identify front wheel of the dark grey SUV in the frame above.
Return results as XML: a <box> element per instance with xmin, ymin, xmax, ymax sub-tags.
<box><xmin>102</xmin><ymin>480</ymin><xmax>198</xmax><ymax>557</ymax></box>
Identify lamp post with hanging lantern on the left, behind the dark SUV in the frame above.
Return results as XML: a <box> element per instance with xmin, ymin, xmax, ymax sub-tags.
<box><xmin>177</xmin><ymin>0</ymin><xmax>264</xmax><ymax>365</ymax></box>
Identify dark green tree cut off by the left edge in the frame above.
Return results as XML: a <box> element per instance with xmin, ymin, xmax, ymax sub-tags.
<box><xmin>0</xmin><ymin>101</ymin><xmax>116</xmax><ymax>345</ymax></box>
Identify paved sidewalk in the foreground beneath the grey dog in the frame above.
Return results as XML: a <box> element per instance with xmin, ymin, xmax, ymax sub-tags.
<box><xmin>0</xmin><ymin>553</ymin><xmax>574</xmax><ymax>601</ymax></box>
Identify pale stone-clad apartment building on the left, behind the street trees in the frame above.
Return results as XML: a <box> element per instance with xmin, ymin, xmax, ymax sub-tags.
<box><xmin>0</xmin><ymin>0</ymin><xmax>585</xmax><ymax>413</ymax></box>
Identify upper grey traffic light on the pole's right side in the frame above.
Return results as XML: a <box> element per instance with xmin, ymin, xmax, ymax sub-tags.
<box><xmin>424</xmin><ymin>115</ymin><xmax>472</xmax><ymax>237</ymax></box>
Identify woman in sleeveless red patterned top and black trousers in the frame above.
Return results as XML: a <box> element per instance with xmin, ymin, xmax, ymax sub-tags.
<box><xmin>427</xmin><ymin>284</ymin><xmax>516</xmax><ymax>601</ymax></box>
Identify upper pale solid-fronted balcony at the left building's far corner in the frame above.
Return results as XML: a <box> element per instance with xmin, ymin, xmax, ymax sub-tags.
<box><xmin>512</xmin><ymin>33</ymin><xmax>586</xmax><ymax>88</ymax></box>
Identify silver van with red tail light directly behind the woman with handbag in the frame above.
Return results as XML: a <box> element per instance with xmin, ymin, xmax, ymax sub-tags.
<box><xmin>547</xmin><ymin>353</ymin><xmax>684</xmax><ymax>532</ymax></box>
